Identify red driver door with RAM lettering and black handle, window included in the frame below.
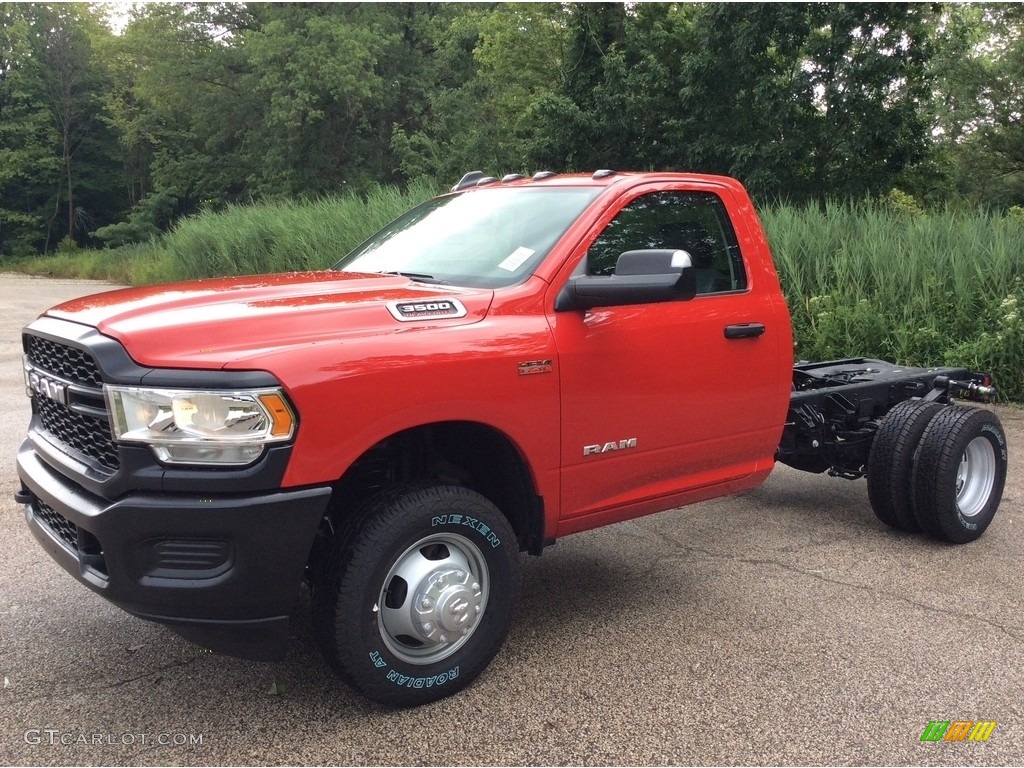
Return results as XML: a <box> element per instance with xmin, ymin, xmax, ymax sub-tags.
<box><xmin>551</xmin><ymin>185</ymin><xmax>793</xmax><ymax>532</ymax></box>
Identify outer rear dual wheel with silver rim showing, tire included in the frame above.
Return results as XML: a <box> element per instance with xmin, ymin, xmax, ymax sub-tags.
<box><xmin>912</xmin><ymin>406</ymin><xmax>1007</xmax><ymax>544</ymax></box>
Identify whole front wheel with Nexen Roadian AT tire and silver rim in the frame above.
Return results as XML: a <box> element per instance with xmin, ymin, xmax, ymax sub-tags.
<box><xmin>312</xmin><ymin>485</ymin><xmax>520</xmax><ymax>707</ymax></box>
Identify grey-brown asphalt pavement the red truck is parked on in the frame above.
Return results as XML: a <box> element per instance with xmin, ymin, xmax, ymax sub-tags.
<box><xmin>0</xmin><ymin>274</ymin><xmax>1024</xmax><ymax>765</ymax></box>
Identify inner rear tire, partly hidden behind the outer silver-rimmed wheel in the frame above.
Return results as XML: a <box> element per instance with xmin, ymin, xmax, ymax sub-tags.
<box><xmin>867</xmin><ymin>400</ymin><xmax>943</xmax><ymax>534</ymax></box>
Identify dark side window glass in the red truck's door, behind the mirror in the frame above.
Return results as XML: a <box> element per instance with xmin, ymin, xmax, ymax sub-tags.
<box><xmin>587</xmin><ymin>191</ymin><xmax>746</xmax><ymax>294</ymax></box>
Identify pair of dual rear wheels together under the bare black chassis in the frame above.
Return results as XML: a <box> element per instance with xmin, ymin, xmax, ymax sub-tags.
<box><xmin>867</xmin><ymin>400</ymin><xmax>1007</xmax><ymax>544</ymax></box>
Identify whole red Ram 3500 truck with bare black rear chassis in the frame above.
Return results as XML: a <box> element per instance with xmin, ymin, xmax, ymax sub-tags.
<box><xmin>16</xmin><ymin>171</ymin><xmax>1007</xmax><ymax>706</ymax></box>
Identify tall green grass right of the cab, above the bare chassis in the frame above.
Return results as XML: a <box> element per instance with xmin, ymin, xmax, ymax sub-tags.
<box><xmin>762</xmin><ymin>198</ymin><xmax>1024</xmax><ymax>400</ymax></box>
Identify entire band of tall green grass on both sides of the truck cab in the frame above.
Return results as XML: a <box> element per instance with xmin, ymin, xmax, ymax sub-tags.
<box><xmin>8</xmin><ymin>186</ymin><xmax>1024</xmax><ymax>401</ymax></box>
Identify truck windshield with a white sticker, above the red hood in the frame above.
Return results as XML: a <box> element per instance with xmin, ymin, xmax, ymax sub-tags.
<box><xmin>334</xmin><ymin>186</ymin><xmax>601</xmax><ymax>288</ymax></box>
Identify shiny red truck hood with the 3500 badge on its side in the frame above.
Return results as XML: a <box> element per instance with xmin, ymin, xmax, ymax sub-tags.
<box><xmin>46</xmin><ymin>271</ymin><xmax>494</xmax><ymax>368</ymax></box>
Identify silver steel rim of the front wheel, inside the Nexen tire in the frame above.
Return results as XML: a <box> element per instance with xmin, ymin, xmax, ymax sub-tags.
<box><xmin>374</xmin><ymin>534</ymin><xmax>490</xmax><ymax>665</ymax></box>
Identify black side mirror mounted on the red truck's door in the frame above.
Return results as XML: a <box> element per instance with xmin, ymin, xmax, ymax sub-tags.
<box><xmin>555</xmin><ymin>248</ymin><xmax>697</xmax><ymax>312</ymax></box>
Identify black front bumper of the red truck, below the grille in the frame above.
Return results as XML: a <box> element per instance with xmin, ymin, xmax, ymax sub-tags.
<box><xmin>16</xmin><ymin>440</ymin><xmax>331</xmax><ymax>660</ymax></box>
